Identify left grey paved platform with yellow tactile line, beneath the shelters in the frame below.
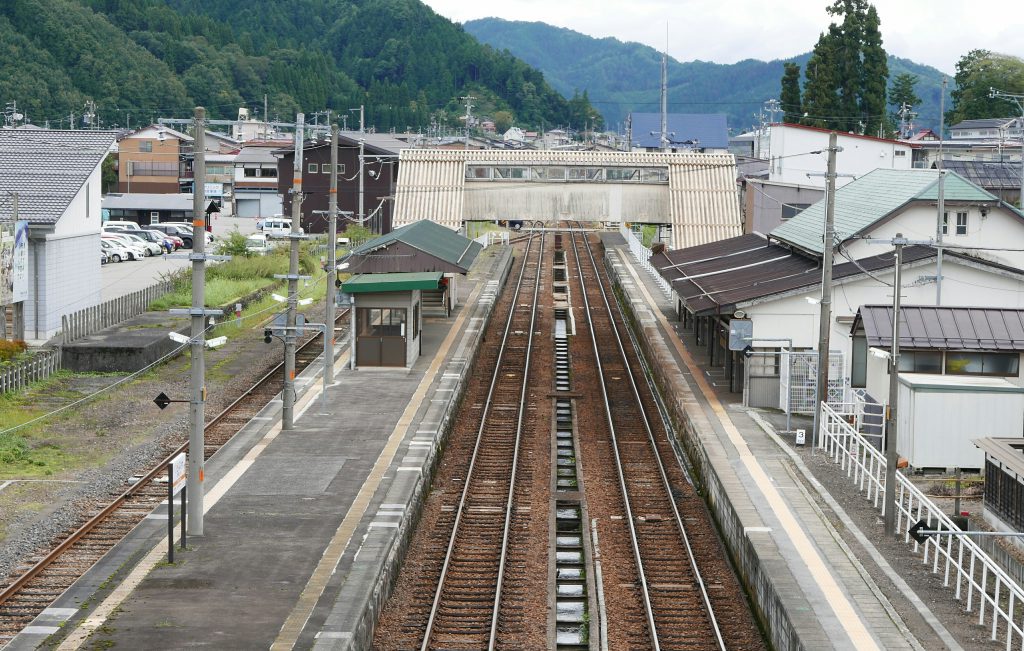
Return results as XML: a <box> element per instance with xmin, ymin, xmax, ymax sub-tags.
<box><xmin>7</xmin><ymin>247</ymin><xmax>511</xmax><ymax>650</ymax></box>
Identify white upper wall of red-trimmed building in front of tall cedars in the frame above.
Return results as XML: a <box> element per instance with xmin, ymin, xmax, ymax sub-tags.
<box><xmin>768</xmin><ymin>125</ymin><xmax>912</xmax><ymax>188</ymax></box>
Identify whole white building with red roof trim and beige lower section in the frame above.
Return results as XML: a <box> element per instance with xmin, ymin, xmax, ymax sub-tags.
<box><xmin>743</xmin><ymin>124</ymin><xmax>913</xmax><ymax>232</ymax></box>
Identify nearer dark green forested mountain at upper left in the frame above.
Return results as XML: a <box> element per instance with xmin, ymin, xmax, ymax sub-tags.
<box><xmin>0</xmin><ymin>0</ymin><xmax>588</xmax><ymax>130</ymax></box>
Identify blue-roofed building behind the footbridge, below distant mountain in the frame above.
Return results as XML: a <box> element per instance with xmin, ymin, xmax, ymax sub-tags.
<box><xmin>629</xmin><ymin>113</ymin><xmax>729</xmax><ymax>154</ymax></box>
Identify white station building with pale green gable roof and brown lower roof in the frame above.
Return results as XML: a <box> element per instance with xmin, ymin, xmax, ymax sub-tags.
<box><xmin>651</xmin><ymin>170</ymin><xmax>1024</xmax><ymax>406</ymax></box>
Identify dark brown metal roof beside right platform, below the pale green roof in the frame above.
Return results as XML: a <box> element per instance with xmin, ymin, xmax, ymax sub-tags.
<box><xmin>650</xmin><ymin>233</ymin><xmax>935</xmax><ymax>314</ymax></box>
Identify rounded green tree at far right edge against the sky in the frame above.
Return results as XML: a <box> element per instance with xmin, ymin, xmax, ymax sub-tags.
<box><xmin>946</xmin><ymin>50</ymin><xmax>1024</xmax><ymax>125</ymax></box>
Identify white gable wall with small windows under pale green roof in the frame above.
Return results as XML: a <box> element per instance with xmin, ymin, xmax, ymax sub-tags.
<box><xmin>844</xmin><ymin>205</ymin><xmax>1024</xmax><ymax>272</ymax></box>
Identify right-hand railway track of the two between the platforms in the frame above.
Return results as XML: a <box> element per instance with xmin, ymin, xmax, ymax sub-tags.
<box><xmin>569</xmin><ymin>226</ymin><xmax>729</xmax><ymax>650</ymax></box>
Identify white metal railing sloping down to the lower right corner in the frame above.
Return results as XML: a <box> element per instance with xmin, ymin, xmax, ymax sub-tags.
<box><xmin>819</xmin><ymin>404</ymin><xmax>1024</xmax><ymax>650</ymax></box>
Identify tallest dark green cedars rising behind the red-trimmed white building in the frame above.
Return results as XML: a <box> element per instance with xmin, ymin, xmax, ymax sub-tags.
<box><xmin>803</xmin><ymin>0</ymin><xmax>889</xmax><ymax>134</ymax></box>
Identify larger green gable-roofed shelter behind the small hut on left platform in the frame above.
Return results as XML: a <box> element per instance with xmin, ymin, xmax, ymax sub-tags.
<box><xmin>344</xmin><ymin>219</ymin><xmax>483</xmax><ymax>316</ymax></box>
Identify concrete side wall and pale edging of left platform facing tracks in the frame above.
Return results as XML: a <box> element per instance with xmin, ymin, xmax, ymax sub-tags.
<box><xmin>335</xmin><ymin>249</ymin><xmax>512</xmax><ymax>650</ymax></box>
